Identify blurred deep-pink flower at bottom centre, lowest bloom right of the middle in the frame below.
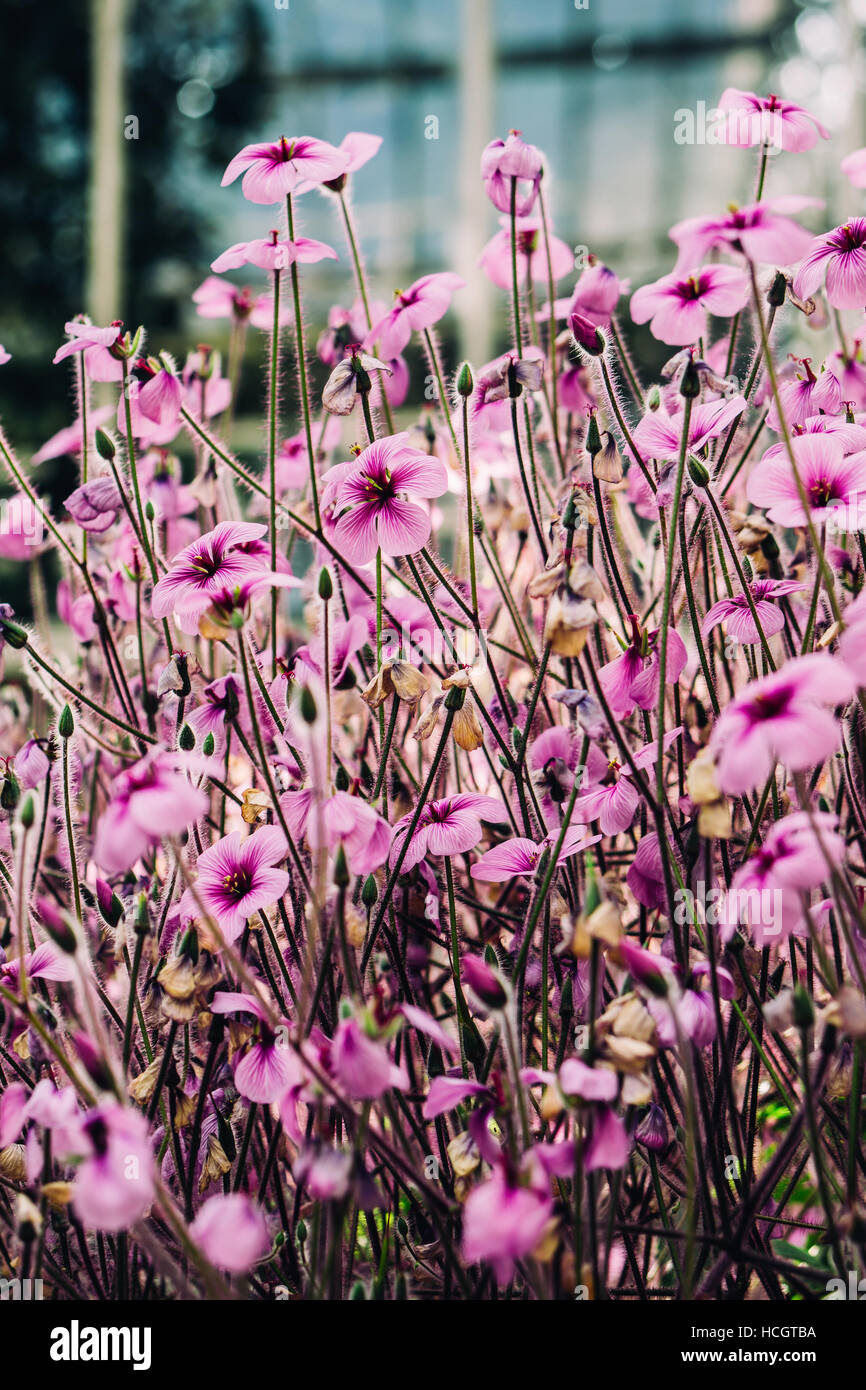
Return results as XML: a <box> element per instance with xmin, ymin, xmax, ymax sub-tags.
<box><xmin>461</xmin><ymin>1168</ymin><xmax>553</xmax><ymax>1283</ymax></box>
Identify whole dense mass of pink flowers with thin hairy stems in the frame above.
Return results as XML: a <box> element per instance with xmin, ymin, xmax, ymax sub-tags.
<box><xmin>0</xmin><ymin>97</ymin><xmax>866</xmax><ymax>1300</ymax></box>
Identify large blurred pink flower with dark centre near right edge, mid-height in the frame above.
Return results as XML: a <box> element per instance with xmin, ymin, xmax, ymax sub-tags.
<box><xmin>710</xmin><ymin>653</ymin><xmax>853</xmax><ymax>795</ymax></box>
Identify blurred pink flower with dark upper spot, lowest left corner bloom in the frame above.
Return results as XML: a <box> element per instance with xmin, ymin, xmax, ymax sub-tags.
<box><xmin>72</xmin><ymin>1101</ymin><xmax>156</xmax><ymax>1230</ymax></box>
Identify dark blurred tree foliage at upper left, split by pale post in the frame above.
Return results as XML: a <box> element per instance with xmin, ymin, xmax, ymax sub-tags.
<box><xmin>0</xmin><ymin>0</ymin><xmax>264</xmax><ymax>443</ymax></box>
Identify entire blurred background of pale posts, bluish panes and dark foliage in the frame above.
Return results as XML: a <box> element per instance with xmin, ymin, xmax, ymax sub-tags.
<box><xmin>0</xmin><ymin>0</ymin><xmax>866</xmax><ymax>597</ymax></box>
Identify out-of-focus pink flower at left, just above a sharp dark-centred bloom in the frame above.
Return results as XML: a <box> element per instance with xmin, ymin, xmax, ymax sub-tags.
<box><xmin>93</xmin><ymin>751</ymin><xmax>210</xmax><ymax>873</ymax></box>
